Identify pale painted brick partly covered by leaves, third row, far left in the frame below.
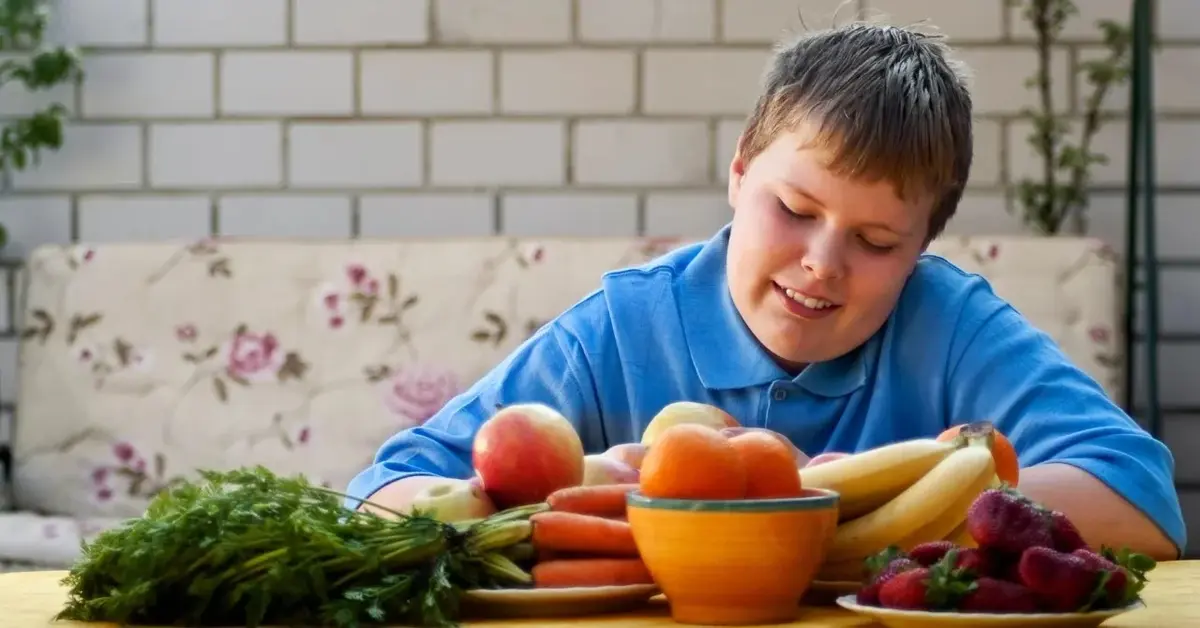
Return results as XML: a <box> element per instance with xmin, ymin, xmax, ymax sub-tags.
<box><xmin>12</xmin><ymin>124</ymin><xmax>143</xmax><ymax>190</ymax></box>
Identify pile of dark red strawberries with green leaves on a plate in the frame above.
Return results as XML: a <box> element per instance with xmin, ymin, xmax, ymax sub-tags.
<box><xmin>857</xmin><ymin>486</ymin><xmax>1156</xmax><ymax>612</ymax></box>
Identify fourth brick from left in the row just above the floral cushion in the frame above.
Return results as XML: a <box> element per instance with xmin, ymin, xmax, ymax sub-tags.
<box><xmin>359</xmin><ymin>192</ymin><xmax>494</xmax><ymax>238</ymax></box>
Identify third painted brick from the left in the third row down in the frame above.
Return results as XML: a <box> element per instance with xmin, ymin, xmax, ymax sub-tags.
<box><xmin>288</xmin><ymin>121</ymin><xmax>422</xmax><ymax>187</ymax></box>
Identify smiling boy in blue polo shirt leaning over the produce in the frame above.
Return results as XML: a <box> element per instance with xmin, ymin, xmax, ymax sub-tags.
<box><xmin>349</xmin><ymin>24</ymin><xmax>1186</xmax><ymax>558</ymax></box>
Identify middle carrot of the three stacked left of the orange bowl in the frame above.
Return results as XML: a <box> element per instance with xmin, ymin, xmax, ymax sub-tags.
<box><xmin>529</xmin><ymin>510</ymin><xmax>640</xmax><ymax>557</ymax></box>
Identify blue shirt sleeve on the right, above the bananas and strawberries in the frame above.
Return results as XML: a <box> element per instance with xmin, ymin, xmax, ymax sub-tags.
<box><xmin>947</xmin><ymin>279</ymin><xmax>1187</xmax><ymax>552</ymax></box>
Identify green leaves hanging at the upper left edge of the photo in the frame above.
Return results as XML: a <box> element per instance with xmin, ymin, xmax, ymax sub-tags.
<box><xmin>0</xmin><ymin>0</ymin><xmax>83</xmax><ymax>247</ymax></box>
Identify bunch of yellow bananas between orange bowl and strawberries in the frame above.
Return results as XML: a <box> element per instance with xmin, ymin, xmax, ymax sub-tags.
<box><xmin>800</xmin><ymin>438</ymin><xmax>1000</xmax><ymax>581</ymax></box>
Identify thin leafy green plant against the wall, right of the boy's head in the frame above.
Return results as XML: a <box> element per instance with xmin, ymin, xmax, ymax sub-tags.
<box><xmin>1008</xmin><ymin>0</ymin><xmax>1130</xmax><ymax>235</ymax></box>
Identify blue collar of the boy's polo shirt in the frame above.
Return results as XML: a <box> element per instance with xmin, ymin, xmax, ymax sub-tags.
<box><xmin>676</xmin><ymin>225</ymin><xmax>877</xmax><ymax>397</ymax></box>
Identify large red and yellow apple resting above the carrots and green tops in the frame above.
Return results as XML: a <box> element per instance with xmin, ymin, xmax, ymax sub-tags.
<box><xmin>472</xmin><ymin>403</ymin><xmax>583</xmax><ymax>509</ymax></box>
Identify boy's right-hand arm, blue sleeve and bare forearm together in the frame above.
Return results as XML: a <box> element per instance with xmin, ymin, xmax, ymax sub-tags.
<box><xmin>947</xmin><ymin>288</ymin><xmax>1187</xmax><ymax>560</ymax></box>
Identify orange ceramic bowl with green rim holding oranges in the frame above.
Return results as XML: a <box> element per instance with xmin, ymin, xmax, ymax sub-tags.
<box><xmin>626</xmin><ymin>489</ymin><xmax>838</xmax><ymax>626</ymax></box>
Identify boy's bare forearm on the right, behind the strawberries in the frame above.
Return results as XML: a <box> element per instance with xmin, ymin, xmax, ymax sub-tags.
<box><xmin>1020</xmin><ymin>463</ymin><xmax>1178</xmax><ymax>561</ymax></box>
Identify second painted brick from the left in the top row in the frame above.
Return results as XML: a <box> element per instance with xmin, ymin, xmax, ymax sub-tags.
<box><xmin>151</xmin><ymin>0</ymin><xmax>288</xmax><ymax>46</ymax></box>
